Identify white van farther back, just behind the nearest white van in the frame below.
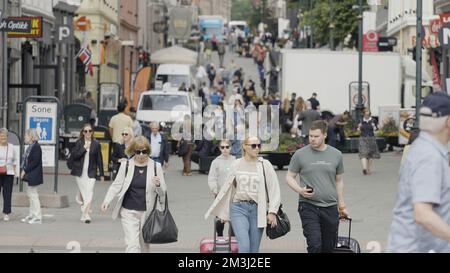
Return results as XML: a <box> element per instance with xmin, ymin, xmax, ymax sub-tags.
<box><xmin>155</xmin><ymin>64</ymin><xmax>195</xmax><ymax>90</ymax></box>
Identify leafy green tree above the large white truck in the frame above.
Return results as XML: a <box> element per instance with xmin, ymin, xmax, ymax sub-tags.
<box><xmin>300</xmin><ymin>0</ymin><xmax>359</xmax><ymax>47</ymax></box>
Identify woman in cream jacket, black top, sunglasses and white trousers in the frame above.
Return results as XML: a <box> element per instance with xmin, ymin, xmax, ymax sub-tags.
<box><xmin>102</xmin><ymin>136</ymin><xmax>167</xmax><ymax>253</ymax></box>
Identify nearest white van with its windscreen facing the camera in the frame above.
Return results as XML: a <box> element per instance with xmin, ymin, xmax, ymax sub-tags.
<box><xmin>136</xmin><ymin>91</ymin><xmax>194</xmax><ymax>131</ymax></box>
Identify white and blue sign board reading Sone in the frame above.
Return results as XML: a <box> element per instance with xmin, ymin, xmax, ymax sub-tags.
<box><xmin>25</xmin><ymin>102</ymin><xmax>58</xmax><ymax>145</ymax></box>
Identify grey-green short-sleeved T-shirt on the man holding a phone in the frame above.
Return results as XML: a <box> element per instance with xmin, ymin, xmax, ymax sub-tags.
<box><xmin>289</xmin><ymin>145</ymin><xmax>344</xmax><ymax>207</ymax></box>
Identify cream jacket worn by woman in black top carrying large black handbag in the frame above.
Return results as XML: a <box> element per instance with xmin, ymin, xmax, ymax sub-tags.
<box><xmin>103</xmin><ymin>159</ymin><xmax>167</xmax><ymax>220</ymax></box>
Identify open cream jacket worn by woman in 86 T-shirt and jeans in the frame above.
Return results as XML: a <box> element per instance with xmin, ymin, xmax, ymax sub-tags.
<box><xmin>205</xmin><ymin>158</ymin><xmax>281</xmax><ymax>228</ymax></box>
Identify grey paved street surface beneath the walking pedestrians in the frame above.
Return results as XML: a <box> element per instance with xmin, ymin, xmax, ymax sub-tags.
<box><xmin>0</xmin><ymin>152</ymin><xmax>400</xmax><ymax>253</ymax></box>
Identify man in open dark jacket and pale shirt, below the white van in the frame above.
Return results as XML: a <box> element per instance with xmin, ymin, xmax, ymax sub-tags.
<box><xmin>144</xmin><ymin>122</ymin><xmax>169</xmax><ymax>169</ymax></box>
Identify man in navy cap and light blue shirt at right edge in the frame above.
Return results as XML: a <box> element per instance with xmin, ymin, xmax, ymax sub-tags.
<box><xmin>387</xmin><ymin>92</ymin><xmax>450</xmax><ymax>253</ymax></box>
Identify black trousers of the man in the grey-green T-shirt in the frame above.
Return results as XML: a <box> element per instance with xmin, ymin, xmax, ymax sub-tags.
<box><xmin>298</xmin><ymin>202</ymin><xmax>339</xmax><ymax>253</ymax></box>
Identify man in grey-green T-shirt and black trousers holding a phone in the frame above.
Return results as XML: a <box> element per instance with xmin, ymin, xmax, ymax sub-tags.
<box><xmin>286</xmin><ymin>120</ymin><xmax>348</xmax><ymax>253</ymax></box>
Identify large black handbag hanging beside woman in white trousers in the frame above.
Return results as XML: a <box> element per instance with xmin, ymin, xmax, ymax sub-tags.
<box><xmin>142</xmin><ymin>193</ymin><xmax>178</xmax><ymax>244</ymax></box>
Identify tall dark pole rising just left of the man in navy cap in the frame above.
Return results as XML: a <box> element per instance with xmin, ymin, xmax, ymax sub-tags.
<box><xmin>415</xmin><ymin>0</ymin><xmax>423</xmax><ymax>128</ymax></box>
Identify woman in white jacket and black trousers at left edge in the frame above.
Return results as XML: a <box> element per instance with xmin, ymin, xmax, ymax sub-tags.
<box><xmin>0</xmin><ymin>128</ymin><xmax>18</xmax><ymax>222</ymax></box>
